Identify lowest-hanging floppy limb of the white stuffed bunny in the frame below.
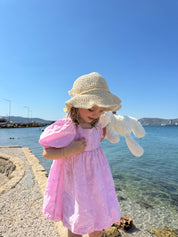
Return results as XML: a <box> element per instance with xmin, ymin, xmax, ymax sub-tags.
<box><xmin>125</xmin><ymin>135</ymin><xmax>144</xmax><ymax>157</ymax></box>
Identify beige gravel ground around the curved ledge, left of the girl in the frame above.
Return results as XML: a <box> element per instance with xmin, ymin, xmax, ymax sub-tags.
<box><xmin>0</xmin><ymin>148</ymin><xmax>60</xmax><ymax>237</ymax></box>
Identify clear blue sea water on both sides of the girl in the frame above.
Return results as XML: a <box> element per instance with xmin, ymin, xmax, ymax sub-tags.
<box><xmin>0</xmin><ymin>126</ymin><xmax>178</xmax><ymax>228</ymax></box>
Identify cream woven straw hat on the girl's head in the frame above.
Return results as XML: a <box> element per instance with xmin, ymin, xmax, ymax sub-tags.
<box><xmin>65</xmin><ymin>72</ymin><xmax>121</xmax><ymax>111</ymax></box>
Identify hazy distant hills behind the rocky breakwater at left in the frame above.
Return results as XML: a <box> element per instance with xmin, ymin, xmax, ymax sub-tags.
<box><xmin>2</xmin><ymin>116</ymin><xmax>52</xmax><ymax>124</ymax></box>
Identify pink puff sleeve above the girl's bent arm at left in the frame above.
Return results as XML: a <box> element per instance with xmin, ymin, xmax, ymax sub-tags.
<box><xmin>39</xmin><ymin>118</ymin><xmax>76</xmax><ymax>148</ymax></box>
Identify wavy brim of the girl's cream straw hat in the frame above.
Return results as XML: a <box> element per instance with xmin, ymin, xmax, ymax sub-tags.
<box><xmin>65</xmin><ymin>91</ymin><xmax>121</xmax><ymax>111</ymax></box>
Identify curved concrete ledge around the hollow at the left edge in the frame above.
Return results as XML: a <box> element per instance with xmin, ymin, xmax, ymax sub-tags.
<box><xmin>0</xmin><ymin>152</ymin><xmax>25</xmax><ymax>195</ymax></box>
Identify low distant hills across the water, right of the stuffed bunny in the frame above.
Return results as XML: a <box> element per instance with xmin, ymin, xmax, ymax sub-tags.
<box><xmin>139</xmin><ymin>118</ymin><xmax>178</xmax><ymax>126</ymax></box>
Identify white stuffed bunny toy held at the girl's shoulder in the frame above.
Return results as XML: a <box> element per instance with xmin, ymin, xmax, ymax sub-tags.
<box><xmin>100</xmin><ymin>112</ymin><xmax>145</xmax><ymax>157</ymax></box>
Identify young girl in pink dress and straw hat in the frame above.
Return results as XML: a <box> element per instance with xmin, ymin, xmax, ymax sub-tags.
<box><xmin>39</xmin><ymin>72</ymin><xmax>121</xmax><ymax>237</ymax></box>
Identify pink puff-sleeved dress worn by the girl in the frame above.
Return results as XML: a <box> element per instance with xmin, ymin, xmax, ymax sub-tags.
<box><xmin>39</xmin><ymin>118</ymin><xmax>120</xmax><ymax>235</ymax></box>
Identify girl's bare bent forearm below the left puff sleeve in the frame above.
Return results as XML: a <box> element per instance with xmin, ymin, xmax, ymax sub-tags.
<box><xmin>43</xmin><ymin>138</ymin><xmax>86</xmax><ymax>160</ymax></box>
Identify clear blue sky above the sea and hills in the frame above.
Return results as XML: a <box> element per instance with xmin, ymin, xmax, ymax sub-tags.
<box><xmin>0</xmin><ymin>0</ymin><xmax>178</xmax><ymax>120</ymax></box>
